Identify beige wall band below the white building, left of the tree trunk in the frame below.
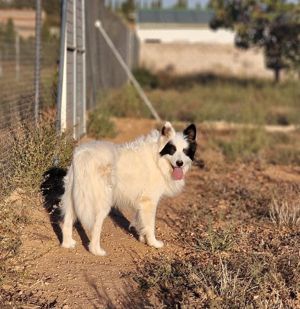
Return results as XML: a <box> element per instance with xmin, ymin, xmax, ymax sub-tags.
<box><xmin>140</xmin><ymin>43</ymin><xmax>273</xmax><ymax>78</ymax></box>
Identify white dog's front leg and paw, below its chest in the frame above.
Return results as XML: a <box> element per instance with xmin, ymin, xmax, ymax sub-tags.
<box><xmin>139</xmin><ymin>199</ymin><xmax>164</xmax><ymax>248</ymax></box>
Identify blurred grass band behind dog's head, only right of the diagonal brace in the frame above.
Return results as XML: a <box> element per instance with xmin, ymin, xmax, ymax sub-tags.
<box><xmin>148</xmin><ymin>75</ymin><xmax>300</xmax><ymax>125</ymax></box>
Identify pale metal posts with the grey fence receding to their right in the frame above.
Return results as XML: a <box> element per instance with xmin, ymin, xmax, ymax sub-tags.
<box><xmin>58</xmin><ymin>0</ymin><xmax>139</xmax><ymax>139</ymax></box>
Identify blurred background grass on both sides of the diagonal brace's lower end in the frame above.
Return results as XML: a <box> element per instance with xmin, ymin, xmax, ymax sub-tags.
<box><xmin>101</xmin><ymin>70</ymin><xmax>300</xmax><ymax>125</ymax></box>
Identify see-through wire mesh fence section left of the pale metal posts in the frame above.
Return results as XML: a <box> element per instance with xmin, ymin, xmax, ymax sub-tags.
<box><xmin>0</xmin><ymin>1</ymin><xmax>59</xmax><ymax>177</ymax></box>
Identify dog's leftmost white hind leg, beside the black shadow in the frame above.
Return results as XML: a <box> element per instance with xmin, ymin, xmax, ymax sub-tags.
<box><xmin>61</xmin><ymin>167</ymin><xmax>76</xmax><ymax>248</ymax></box>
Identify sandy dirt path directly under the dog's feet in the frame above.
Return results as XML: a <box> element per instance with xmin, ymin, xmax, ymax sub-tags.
<box><xmin>23</xmin><ymin>201</ymin><xmax>183</xmax><ymax>308</ymax></box>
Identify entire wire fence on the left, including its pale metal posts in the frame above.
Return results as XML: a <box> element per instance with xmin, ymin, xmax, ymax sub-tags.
<box><xmin>0</xmin><ymin>0</ymin><xmax>139</xmax><ymax>177</ymax></box>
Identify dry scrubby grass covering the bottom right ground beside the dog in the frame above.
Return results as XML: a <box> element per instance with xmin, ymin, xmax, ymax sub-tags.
<box><xmin>134</xmin><ymin>163</ymin><xmax>300</xmax><ymax>309</ymax></box>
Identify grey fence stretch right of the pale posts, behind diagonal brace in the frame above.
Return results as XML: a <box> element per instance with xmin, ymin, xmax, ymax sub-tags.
<box><xmin>86</xmin><ymin>0</ymin><xmax>139</xmax><ymax>108</ymax></box>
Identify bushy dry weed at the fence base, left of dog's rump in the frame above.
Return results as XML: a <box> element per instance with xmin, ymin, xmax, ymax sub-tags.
<box><xmin>6</xmin><ymin>122</ymin><xmax>74</xmax><ymax>192</ymax></box>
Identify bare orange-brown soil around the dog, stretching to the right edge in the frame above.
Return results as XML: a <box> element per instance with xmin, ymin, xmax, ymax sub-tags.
<box><xmin>6</xmin><ymin>119</ymin><xmax>300</xmax><ymax>308</ymax></box>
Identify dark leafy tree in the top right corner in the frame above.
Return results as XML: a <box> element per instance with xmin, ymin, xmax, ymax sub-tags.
<box><xmin>210</xmin><ymin>0</ymin><xmax>300</xmax><ymax>82</ymax></box>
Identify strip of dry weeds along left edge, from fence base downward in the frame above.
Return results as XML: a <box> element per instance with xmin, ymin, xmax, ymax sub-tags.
<box><xmin>0</xmin><ymin>121</ymin><xmax>74</xmax><ymax>308</ymax></box>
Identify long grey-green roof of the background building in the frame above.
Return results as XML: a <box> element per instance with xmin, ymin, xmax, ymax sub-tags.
<box><xmin>137</xmin><ymin>9</ymin><xmax>213</xmax><ymax>25</ymax></box>
